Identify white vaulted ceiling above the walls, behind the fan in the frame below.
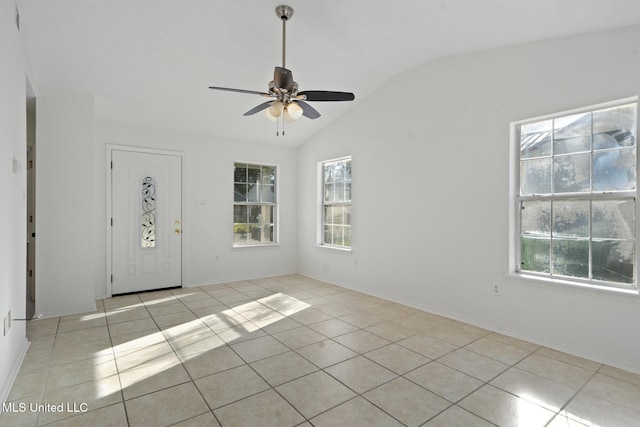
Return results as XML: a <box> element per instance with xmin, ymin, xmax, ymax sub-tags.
<box><xmin>16</xmin><ymin>0</ymin><xmax>640</xmax><ymax>146</ymax></box>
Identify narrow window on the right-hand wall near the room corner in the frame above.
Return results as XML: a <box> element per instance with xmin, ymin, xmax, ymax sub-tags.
<box><xmin>320</xmin><ymin>157</ymin><xmax>351</xmax><ymax>248</ymax></box>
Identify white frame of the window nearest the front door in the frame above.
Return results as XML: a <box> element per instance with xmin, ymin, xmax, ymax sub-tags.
<box><xmin>232</xmin><ymin>161</ymin><xmax>280</xmax><ymax>249</ymax></box>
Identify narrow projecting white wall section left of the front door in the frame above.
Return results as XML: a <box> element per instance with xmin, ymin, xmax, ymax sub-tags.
<box><xmin>35</xmin><ymin>86</ymin><xmax>95</xmax><ymax>317</ymax></box>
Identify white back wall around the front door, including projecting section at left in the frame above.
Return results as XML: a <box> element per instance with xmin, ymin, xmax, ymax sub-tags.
<box><xmin>31</xmin><ymin>87</ymin><xmax>296</xmax><ymax>317</ymax></box>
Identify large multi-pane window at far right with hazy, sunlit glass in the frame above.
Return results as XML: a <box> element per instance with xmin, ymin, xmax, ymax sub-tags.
<box><xmin>514</xmin><ymin>101</ymin><xmax>637</xmax><ymax>289</ymax></box>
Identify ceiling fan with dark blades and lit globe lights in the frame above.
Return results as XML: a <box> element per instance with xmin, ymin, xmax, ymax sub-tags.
<box><xmin>209</xmin><ymin>5</ymin><xmax>355</xmax><ymax>135</ymax></box>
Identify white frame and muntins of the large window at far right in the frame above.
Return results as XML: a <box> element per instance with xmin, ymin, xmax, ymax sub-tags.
<box><xmin>509</xmin><ymin>96</ymin><xmax>640</xmax><ymax>295</ymax></box>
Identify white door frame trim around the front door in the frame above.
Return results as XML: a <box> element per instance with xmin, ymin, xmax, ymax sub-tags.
<box><xmin>104</xmin><ymin>144</ymin><xmax>185</xmax><ymax>298</ymax></box>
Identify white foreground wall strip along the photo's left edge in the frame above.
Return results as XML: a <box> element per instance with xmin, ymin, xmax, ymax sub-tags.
<box><xmin>0</xmin><ymin>2</ymin><xmax>28</xmax><ymax>402</ymax></box>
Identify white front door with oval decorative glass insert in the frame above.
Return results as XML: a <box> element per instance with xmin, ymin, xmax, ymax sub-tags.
<box><xmin>111</xmin><ymin>149</ymin><xmax>182</xmax><ymax>294</ymax></box>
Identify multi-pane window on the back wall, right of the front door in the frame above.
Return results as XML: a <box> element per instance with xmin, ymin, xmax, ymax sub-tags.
<box><xmin>233</xmin><ymin>163</ymin><xmax>278</xmax><ymax>246</ymax></box>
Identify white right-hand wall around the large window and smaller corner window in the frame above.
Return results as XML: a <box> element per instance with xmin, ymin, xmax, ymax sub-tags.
<box><xmin>298</xmin><ymin>26</ymin><xmax>640</xmax><ymax>372</ymax></box>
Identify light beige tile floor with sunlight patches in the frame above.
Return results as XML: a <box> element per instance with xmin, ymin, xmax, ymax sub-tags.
<box><xmin>0</xmin><ymin>275</ymin><xmax>640</xmax><ymax>427</ymax></box>
